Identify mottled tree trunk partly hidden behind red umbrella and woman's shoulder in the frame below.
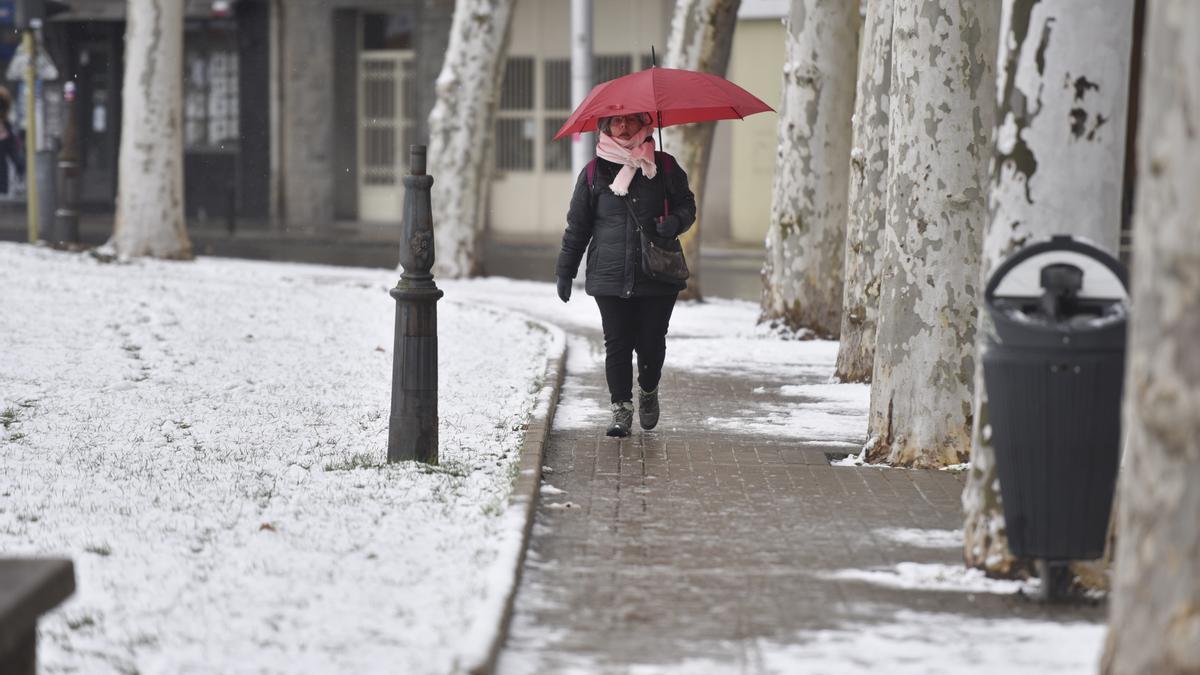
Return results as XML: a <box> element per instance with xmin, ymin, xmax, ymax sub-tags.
<box><xmin>661</xmin><ymin>0</ymin><xmax>742</xmax><ymax>300</ymax></box>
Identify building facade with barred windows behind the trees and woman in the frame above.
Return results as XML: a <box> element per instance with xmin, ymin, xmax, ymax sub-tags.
<box><xmin>11</xmin><ymin>0</ymin><xmax>784</xmax><ymax>253</ymax></box>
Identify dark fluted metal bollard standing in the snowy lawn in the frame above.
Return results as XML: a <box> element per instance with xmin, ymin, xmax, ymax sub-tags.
<box><xmin>388</xmin><ymin>145</ymin><xmax>443</xmax><ymax>464</ymax></box>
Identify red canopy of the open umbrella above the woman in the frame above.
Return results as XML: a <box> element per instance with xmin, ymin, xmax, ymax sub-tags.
<box><xmin>554</xmin><ymin>67</ymin><xmax>774</xmax><ymax>141</ymax></box>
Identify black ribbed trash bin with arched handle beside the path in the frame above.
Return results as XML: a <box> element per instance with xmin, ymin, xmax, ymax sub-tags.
<box><xmin>983</xmin><ymin>237</ymin><xmax>1128</xmax><ymax>564</ymax></box>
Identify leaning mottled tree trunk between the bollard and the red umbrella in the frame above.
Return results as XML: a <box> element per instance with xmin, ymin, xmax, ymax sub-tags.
<box><xmin>428</xmin><ymin>0</ymin><xmax>514</xmax><ymax>277</ymax></box>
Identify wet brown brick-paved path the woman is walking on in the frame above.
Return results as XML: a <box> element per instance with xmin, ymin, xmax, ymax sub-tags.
<box><xmin>498</xmin><ymin>324</ymin><xmax>1103</xmax><ymax>675</ymax></box>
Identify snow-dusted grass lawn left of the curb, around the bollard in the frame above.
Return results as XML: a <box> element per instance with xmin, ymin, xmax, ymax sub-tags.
<box><xmin>0</xmin><ymin>244</ymin><xmax>551</xmax><ymax>675</ymax></box>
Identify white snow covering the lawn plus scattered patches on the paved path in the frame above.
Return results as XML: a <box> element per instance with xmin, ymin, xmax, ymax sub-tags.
<box><xmin>0</xmin><ymin>244</ymin><xmax>1103</xmax><ymax>675</ymax></box>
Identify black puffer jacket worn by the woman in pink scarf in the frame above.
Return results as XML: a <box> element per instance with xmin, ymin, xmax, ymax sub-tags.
<box><xmin>556</xmin><ymin>153</ymin><xmax>696</xmax><ymax>298</ymax></box>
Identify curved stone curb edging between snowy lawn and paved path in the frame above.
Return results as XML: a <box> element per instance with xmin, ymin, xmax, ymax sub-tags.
<box><xmin>458</xmin><ymin>312</ymin><xmax>566</xmax><ymax>675</ymax></box>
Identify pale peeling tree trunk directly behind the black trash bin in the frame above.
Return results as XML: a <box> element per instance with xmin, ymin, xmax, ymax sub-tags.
<box><xmin>962</xmin><ymin>0</ymin><xmax>1133</xmax><ymax>577</ymax></box>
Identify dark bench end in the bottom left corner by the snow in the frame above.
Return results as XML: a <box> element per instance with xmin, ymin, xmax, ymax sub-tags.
<box><xmin>0</xmin><ymin>558</ymin><xmax>74</xmax><ymax>675</ymax></box>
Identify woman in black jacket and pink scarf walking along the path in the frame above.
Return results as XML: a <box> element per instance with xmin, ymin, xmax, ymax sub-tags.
<box><xmin>556</xmin><ymin>113</ymin><xmax>696</xmax><ymax>436</ymax></box>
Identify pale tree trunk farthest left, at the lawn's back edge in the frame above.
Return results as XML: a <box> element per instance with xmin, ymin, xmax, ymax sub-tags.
<box><xmin>108</xmin><ymin>0</ymin><xmax>192</xmax><ymax>259</ymax></box>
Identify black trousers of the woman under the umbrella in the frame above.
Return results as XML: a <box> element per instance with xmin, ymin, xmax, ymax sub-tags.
<box><xmin>595</xmin><ymin>293</ymin><xmax>678</xmax><ymax>404</ymax></box>
